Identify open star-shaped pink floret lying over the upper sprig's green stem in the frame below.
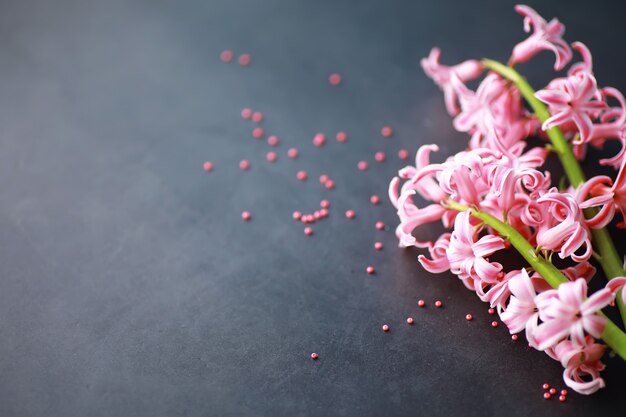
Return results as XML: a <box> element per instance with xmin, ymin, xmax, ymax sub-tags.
<box><xmin>535</xmin><ymin>71</ymin><xmax>606</xmax><ymax>144</ymax></box>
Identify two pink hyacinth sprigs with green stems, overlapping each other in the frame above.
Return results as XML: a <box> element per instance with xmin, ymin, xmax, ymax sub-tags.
<box><xmin>389</xmin><ymin>5</ymin><xmax>626</xmax><ymax>394</ymax></box>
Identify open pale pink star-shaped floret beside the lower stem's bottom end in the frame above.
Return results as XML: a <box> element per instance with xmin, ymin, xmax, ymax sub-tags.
<box><xmin>533</xmin><ymin>278</ymin><xmax>613</xmax><ymax>350</ymax></box>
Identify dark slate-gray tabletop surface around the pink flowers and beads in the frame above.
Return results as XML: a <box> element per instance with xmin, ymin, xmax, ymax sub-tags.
<box><xmin>0</xmin><ymin>0</ymin><xmax>626</xmax><ymax>416</ymax></box>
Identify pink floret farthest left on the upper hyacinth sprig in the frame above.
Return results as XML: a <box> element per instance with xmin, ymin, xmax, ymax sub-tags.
<box><xmin>421</xmin><ymin>48</ymin><xmax>483</xmax><ymax>116</ymax></box>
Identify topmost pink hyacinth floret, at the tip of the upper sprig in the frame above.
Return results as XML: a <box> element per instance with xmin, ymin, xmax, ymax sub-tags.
<box><xmin>510</xmin><ymin>4</ymin><xmax>572</xmax><ymax>71</ymax></box>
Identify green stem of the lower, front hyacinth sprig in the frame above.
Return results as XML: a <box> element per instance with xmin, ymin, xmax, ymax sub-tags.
<box><xmin>444</xmin><ymin>200</ymin><xmax>626</xmax><ymax>360</ymax></box>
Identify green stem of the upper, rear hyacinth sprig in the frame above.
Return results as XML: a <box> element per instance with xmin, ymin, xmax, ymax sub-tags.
<box><xmin>483</xmin><ymin>59</ymin><xmax>626</xmax><ymax>324</ymax></box>
